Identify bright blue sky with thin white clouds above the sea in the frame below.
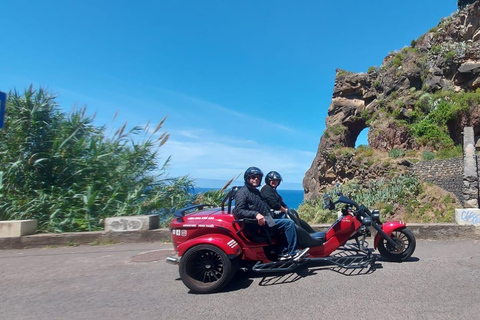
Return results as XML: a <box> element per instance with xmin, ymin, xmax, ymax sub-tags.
<box><xmin>0</xmin><ymin>0</ymin><xmax>457</xmax><ymax>188</ymax></box>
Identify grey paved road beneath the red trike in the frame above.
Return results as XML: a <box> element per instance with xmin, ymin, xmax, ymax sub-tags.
<box><xmin>0</xmin><ymin>240</ymin><xmax>480</xmax><ymax>320</ymax></box>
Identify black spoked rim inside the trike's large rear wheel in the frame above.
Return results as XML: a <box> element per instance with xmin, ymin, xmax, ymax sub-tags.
<box><xmin>186</xmin><ymin>250</ymin><xmax>223</xmax><ymax>283</ymax></box>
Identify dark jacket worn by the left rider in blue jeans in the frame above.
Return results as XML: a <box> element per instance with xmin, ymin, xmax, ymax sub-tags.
<box><xmin>233</xmin><ymin>185</ymin><xmax>270</xmax><ymax>219</ymax></box>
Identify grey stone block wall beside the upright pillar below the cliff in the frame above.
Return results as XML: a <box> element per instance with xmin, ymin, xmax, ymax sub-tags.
<box><xmin>413</xmin><ymin>157</ymin><xmax>464</xmax><ymax>205</ymax></box>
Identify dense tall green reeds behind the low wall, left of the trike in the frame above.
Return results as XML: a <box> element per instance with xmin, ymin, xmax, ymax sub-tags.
<box><xmin>0</xmin><ymin>87</ymin><xmax>193</xmax><ymax>232</ymax></box>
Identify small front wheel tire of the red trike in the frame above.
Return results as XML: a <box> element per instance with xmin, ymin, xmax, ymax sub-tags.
<box><xmin>378</xmin><ymin>228</ymin><xmax>416</xmax><ymax>262</ymax></box>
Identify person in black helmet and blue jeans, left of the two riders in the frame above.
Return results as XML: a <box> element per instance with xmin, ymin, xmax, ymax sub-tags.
<box><xmin>233</xmin><ymin>167</ymin><xmax>308</xmax><ymax>260</ymax></box>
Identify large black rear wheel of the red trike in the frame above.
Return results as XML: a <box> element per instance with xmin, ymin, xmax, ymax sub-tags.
<box><xmin>179</xmin><ymin>244</ymin><xmax>238</xmax><ymax>293</ymax></box>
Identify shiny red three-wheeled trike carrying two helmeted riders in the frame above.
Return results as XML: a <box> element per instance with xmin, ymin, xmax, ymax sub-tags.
<box><xmin>167</xmin><ymin>187</ymin><xmax>416</xmax><ymax>293</ymax></box>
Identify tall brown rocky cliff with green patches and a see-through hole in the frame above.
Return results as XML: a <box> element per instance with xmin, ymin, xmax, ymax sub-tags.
<box><xmin>303</xmin><ymin>0</ymin><xmax>480</xmax><ymax>200</ymax></box>
